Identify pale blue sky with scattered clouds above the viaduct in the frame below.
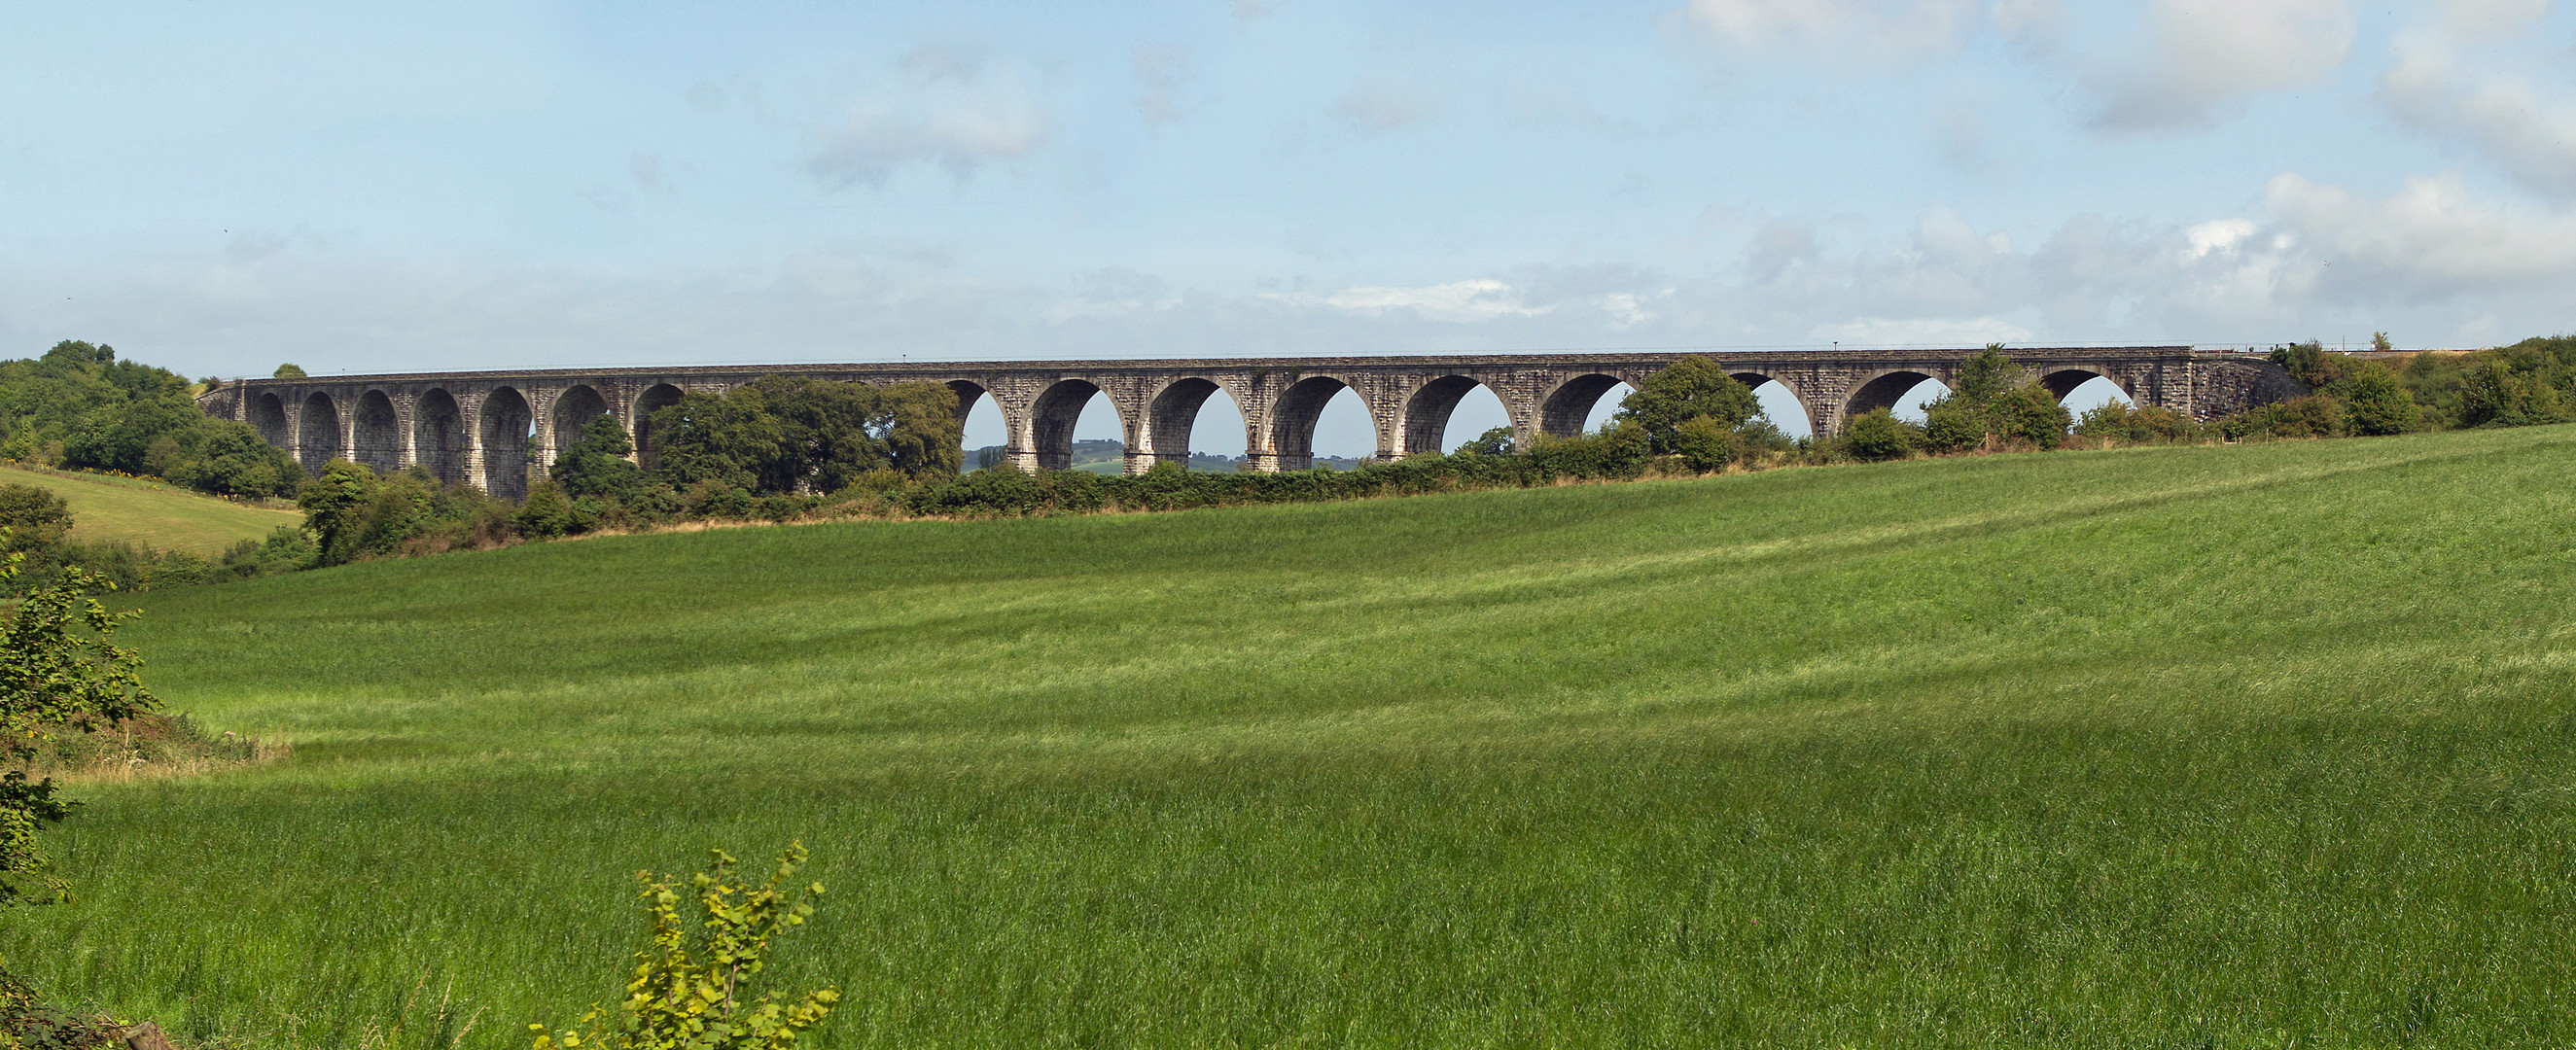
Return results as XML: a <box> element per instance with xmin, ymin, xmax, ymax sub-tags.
<box><xmin>0</xmin><ymin>0</ymin><xmax>2576</xmax><ymax>450</ymax></box>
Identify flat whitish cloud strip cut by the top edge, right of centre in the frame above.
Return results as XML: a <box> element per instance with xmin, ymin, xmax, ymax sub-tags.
<box><xmin>1679</xmin><ymin>0</ymin><xmax>1976</xmax><ymax>59</ymax></box>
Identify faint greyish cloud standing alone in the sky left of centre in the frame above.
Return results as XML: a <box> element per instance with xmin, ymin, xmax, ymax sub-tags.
<box><xmin>806</xmin><ymin>47</ymin><xmax>1051</xmax><ymax>188</ymax></box>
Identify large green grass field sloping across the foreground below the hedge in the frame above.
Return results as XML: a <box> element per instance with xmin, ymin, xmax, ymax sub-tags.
<box><xmin>0</xmin><ymin>427</ymin><xmax>2576</xmax><ymax>1047</ymax></box>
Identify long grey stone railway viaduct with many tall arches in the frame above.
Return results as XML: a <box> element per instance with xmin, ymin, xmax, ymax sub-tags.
<box><xmin>198</xmin><ymin>347</ymin><xmax>2306</xmax><ymax>497</ymax></box>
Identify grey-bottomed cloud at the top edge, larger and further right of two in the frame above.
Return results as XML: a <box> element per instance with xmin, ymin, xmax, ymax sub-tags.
<box><xmin>2087</xmin><ymin>0</ymin><xmax>2354</xmax><ymax>131</ymax></box>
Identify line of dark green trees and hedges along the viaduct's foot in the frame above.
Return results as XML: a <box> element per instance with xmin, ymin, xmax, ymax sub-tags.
<box><xmin>0</xmin><ymin>337</ymin><xmax>2576</xmax><ymax>574</ymax></box>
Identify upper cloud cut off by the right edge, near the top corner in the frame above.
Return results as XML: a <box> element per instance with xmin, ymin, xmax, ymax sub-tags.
<box><xmin>2381</xmin><ymin>41</ymin><xmax>2576</xmax><ymax>198</ymax></box>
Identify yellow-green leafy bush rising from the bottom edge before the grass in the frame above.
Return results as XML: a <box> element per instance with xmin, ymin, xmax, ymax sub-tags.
<box><xmin>531</xmin><ymin>842</ymin><xmax>840</xmax><ymax>1050</ymax></box>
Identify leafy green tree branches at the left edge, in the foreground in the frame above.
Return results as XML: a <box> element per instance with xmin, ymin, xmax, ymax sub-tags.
<box><xmin>0</xmin><ymin>532</ymin><xmax>159</xmax><ymax>903</ymax></box>
